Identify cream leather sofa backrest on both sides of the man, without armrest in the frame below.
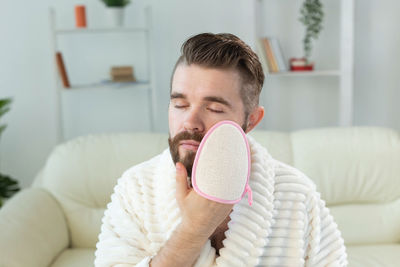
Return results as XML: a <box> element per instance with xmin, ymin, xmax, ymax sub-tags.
<box><xmin>35</xmin><ymin>127</ymin><xmax>400</xmax><ymax>248</ymax></box>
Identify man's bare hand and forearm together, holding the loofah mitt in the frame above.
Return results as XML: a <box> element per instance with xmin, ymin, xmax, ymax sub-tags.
<box><xmin>150</xmin><ymin>163</ymin><xmax>233</xmax><ymax>267</ymax></box>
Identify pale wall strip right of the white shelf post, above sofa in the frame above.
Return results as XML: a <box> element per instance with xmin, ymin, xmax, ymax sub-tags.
<box><xmin>354</xmin><ymin>0</ymin><xmax>400</xmax><ymax>127</ymax></box>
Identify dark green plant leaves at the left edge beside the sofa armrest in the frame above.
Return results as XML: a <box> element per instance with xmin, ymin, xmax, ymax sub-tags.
<box><xmin>0</xmin><ymin>98</ymin><xmax>20</xmax><ymax>207</ymax></box>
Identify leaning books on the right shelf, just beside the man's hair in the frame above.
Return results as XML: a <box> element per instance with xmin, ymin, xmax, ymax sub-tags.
<box><xmin>257</xmin><ymin>37</ymin><xmax>288</xmax><ymax>73</ymax></box>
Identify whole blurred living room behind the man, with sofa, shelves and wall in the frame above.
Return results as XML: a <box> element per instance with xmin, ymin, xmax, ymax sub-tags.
<box><xmin>0</xmin><ymin>0</ymin><xmax>400</xmax><ymax>267</ymax></box>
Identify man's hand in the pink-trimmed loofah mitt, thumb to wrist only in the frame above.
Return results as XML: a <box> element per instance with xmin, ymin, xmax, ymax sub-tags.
<box><xmin>176</xmin><ymin>162</ymin><xmax>233</xmax><ymax>241</ymax></box>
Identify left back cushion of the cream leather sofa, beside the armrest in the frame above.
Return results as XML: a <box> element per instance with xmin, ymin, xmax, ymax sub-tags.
<box><xmin>41</xmin><ymin>133</ymin><xmax>168</xmax><ymax>248</ymax></box>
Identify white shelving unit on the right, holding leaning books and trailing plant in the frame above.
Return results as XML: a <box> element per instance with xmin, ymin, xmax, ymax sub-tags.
<box><xmin>253</xmin><ymin>0</ymin><xmax>354</xmax><ymax>126</ymax></box>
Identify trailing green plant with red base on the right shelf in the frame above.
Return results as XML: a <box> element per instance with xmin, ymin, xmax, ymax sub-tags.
<box><xmin>290</xmin><ymin>0</ymin><xmax>324</xmax><ymax>70</ymax></box>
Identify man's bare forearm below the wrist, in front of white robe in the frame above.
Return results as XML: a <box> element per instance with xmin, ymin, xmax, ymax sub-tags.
<box><xmin>150</xmin><ymin>225</ymin><xmax>209</xmax><ymax>267</ymax></box>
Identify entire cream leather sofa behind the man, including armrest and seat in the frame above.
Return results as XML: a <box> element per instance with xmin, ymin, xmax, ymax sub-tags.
<box><xmin>0</xmin><ymin>127</ymin><xmax>400</xmax><ymax>267</ymax></box>
